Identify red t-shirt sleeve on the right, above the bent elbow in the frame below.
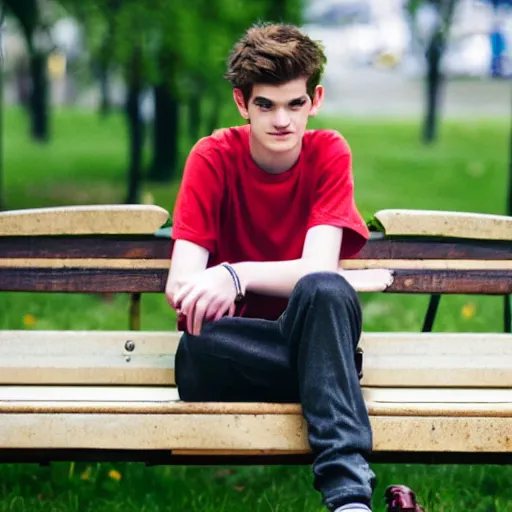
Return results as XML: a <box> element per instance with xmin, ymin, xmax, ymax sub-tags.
<box><xmin>308</xmin><ymin>135</ymin><xmax>369</xmax><ymax>258</ymax></box>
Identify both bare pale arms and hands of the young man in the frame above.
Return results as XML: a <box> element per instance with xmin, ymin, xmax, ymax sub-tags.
<box><xmin>171</xmin><ymin>225</ymin><xmax>393</xmax><ymax>335</ymax></box>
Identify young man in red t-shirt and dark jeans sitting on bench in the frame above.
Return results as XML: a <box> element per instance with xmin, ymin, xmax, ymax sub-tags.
<box><xmin>166</xmin><ymin>25</ymin><xmax>392</xmax><ymax>512</ymax></box>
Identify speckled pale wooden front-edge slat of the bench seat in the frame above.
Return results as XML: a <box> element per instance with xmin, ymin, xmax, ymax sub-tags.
<box><xmin>0</xmin><ymin>413</ymin><xmax>512</xmax><ymax>454</ymax></box>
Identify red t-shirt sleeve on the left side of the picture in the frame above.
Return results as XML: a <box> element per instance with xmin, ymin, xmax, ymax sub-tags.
<box><xmin>171</xmin><ymin>142</ymin><xmax>223</xmax><ymax>253</ymax></box>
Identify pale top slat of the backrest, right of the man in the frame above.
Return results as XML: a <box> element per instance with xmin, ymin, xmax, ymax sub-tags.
<box><xmin>375</xmin><ymin>210</ymin><xmax>512</xmax><ymax>240</ymax></box>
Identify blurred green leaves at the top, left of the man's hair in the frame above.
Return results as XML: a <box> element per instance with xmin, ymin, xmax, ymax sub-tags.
<box><xmin>57</xmin><ymin>0</ymin><xmax>303</xmax><ymax>99</ymax></box>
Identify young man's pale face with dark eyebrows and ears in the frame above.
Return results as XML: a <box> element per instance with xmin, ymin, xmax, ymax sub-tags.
<box><xmin>235</xmin><ymin>78</ymin><xmax>323</xmax><ymax>153</ymax></box>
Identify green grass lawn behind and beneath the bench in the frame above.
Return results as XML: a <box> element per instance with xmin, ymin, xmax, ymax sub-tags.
<box><xmin>0</xmin><ymin>109</ymin><xmax>512</xmax><ymax>512</ymax></box>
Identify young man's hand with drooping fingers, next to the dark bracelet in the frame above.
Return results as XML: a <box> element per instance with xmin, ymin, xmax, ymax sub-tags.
<box><xmin>172</xmin><ymin>265</ymin><xmax>245</xmax><ymax>336</ymax></box>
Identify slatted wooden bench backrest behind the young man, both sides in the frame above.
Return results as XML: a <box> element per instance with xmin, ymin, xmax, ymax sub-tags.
<box><xmin>0</xmin><ymin>206</ymin><xmax>512</xmax><ymax>295</ymax></box>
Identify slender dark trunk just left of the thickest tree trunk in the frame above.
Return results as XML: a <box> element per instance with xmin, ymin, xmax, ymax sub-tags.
<box><xmin>126</xmin><ymin>48</ymin><xmax>144</xmax><ymax>204</ymax></box>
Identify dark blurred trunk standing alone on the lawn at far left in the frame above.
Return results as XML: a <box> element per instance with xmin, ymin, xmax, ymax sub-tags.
<box><xmin>30</xmin><ymin>52</ymin><xmax>49</xmax><ymax>142</ymax></box>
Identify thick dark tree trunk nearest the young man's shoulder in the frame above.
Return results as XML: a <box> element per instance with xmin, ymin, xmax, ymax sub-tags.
<box><xmin>148</xmin><ymin>84</ymin><xmax>179</xmax><ymax>183</ymax></box>
